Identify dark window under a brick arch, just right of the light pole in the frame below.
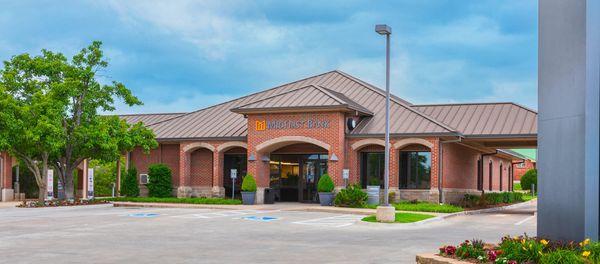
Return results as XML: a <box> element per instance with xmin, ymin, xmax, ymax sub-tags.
<box><xmin>399</xmin><ymin>151</ymin><xmax>431</xmax><ymax>189</ymax></box>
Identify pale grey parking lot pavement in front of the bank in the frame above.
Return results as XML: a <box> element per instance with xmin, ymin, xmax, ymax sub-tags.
<box><xmin>0</xmin><ymin>205</ymin><xmax>536</xmax><ymax>263</ymax></box>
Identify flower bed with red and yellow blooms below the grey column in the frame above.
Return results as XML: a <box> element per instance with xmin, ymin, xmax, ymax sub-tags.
<box><xmin>439</xmin><ymin>235</ymin><xmax>600</xmax><ymax>264</ymax></box>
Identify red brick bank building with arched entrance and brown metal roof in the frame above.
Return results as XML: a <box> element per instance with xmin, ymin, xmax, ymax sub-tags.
<box><xmin>0</xmin><ymin>71</ymin><xmax>537</xmax><ymax>203</ymax></box>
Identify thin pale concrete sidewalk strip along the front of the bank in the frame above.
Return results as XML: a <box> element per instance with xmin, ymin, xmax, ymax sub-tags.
<box><xmin>112</xmin><ymin>202</ymin><xmax>448</xmax><ymax>216</ymax></box>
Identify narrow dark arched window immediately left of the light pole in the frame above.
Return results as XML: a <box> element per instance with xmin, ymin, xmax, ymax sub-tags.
<box><xmin>360</xmin><ymin>152</ymin><xmax>385</xmax><ymax>188</ymax></box>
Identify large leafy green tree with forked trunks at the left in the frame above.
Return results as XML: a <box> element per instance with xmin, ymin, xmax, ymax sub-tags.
<box><xmin>0</xmin><ymin>41</ymin><xmax>158</xmax><ymax>199</ymax></box>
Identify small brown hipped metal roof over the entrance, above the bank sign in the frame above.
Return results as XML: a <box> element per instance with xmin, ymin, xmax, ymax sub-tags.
<box><xmin>231</xmin><ymin>85</ymin><xmax>373</xmax><ymax>116</ymax></box>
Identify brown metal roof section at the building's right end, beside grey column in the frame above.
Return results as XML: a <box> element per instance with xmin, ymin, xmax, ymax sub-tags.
<box><xmin>413</xmin><ymin>103</ymin><xmax>537</xmax><ymax>137</ymax></box>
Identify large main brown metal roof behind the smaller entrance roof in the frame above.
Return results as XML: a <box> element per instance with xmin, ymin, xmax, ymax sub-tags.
<box><xmin>150</xmin><ymin>71</ymin><xmax>455</xmax><ymax>139</ymax></box>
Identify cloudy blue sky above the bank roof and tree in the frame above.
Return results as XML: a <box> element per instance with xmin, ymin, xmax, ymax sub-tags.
<box><xmin>0</xmin><ymin>0</ymin><xmax>537</xmax><ymax>113</ymax></box>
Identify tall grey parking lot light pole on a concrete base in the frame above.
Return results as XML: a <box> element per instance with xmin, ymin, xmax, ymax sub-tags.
<box><xmin>375</xmin><ymin>24</ymin><xmax>395</xmax><ymax>222</ymax></box>
